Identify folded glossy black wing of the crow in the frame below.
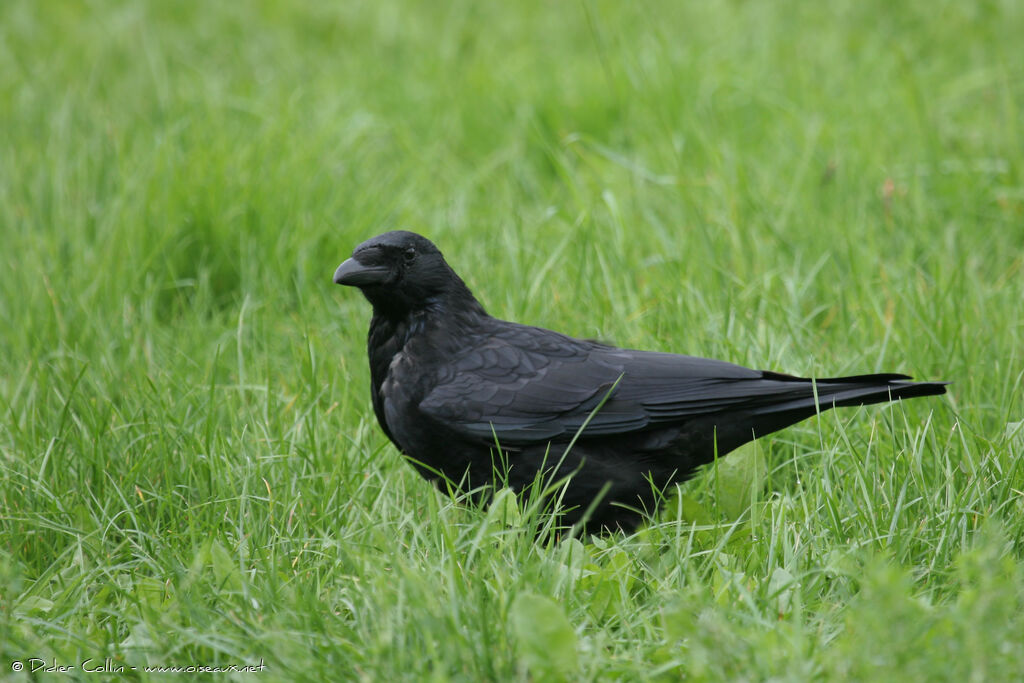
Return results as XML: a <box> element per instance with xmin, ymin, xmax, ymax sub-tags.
<box><xmin>420</xmin><ymin>324</ymin><xmax>813</xmax><ymax>447</ymax></box>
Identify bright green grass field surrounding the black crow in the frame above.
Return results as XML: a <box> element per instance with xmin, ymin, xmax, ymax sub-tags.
<box><xmin>0</xmin><ymin>0</ymin><xmax>1024</xmax><ymax>681</ymax></box>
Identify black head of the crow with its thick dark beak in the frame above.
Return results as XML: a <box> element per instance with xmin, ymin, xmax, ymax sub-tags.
<box><xmin>334</xmin><ymin>230</ymin><xmax>472</xmax><ymax>315</ymax></box>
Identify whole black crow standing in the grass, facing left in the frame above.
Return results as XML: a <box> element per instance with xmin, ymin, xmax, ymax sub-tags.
<box><xmin>334</xmin><ymin>230</ymin><xmax>946</xmax><ymax>531</ymax></box>
